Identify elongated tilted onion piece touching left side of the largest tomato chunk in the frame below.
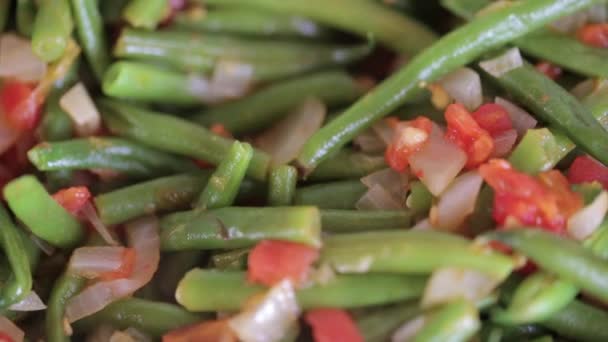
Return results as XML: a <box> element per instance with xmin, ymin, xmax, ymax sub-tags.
<box><xmin>431</xmin><ymin>171</ymin><xmax>483</xmax><ymax>231</ymax></box>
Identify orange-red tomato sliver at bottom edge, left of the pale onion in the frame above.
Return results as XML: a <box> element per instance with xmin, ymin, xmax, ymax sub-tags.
<box><xmin>163</xmin><ymin>319</ymin><xmax>237</xmax><ymax>342</ymax></box>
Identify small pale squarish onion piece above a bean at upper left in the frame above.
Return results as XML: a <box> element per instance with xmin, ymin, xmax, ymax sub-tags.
<box><xmin>59</xmin><ymin>82</ymin><xmax>101</xmax><ymax>137</ymax></box>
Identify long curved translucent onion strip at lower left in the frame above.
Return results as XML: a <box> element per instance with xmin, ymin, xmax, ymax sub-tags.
<box><xmin>65</xmin><ymin>216</ymin><xmax>160</xmax><ymax>323</ymax></box>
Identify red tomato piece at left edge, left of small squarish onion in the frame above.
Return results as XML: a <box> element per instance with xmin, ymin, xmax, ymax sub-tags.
<box><xmin>0</xmin><ymin>80</ymin><xmax>41</xmax><ymax>131</ymax></box>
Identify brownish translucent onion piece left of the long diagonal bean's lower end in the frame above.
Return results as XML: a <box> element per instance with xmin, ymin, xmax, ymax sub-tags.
<box><xmin>256</xmin><ymin>98</ymin><xmax>327</xmax><ymax>165</ymax></box>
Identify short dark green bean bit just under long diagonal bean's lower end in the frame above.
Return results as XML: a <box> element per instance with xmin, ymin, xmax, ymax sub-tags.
<box><xmin>309</xmin><ymin>149</ymin><xmax>386</xmax><ymax>181</ymax></box>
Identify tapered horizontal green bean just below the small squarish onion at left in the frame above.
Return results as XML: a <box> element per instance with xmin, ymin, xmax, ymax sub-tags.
<box><xmin>27</xmin><ymin>137</ymin><xmax>198</xmax><ymax>177</ymax></box>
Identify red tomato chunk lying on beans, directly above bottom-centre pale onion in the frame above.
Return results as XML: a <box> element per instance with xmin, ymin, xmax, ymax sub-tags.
<box><xmin>247</xmin><ymin>240</ymin><xmax>319</xmax><ymax>286</ymax></box>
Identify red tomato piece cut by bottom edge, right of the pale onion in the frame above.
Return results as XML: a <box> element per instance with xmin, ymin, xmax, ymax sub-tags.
<box><xmin>304</xmin><ymin>309</ymin><xmax>363</xmax><ymax>342</ymax></box>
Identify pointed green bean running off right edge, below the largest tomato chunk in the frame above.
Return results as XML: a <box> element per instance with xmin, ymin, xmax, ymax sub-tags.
<box><xmin>487</xmin><ymin>228</ymin><xmax>608</xmax><ymax>300</ymax></box>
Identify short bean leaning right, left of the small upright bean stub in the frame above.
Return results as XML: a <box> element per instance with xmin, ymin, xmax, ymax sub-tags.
<box><xmin>196</xmin><ymin>141</ymin><xmax>253</xmax><ymax>210</ymax></box>
